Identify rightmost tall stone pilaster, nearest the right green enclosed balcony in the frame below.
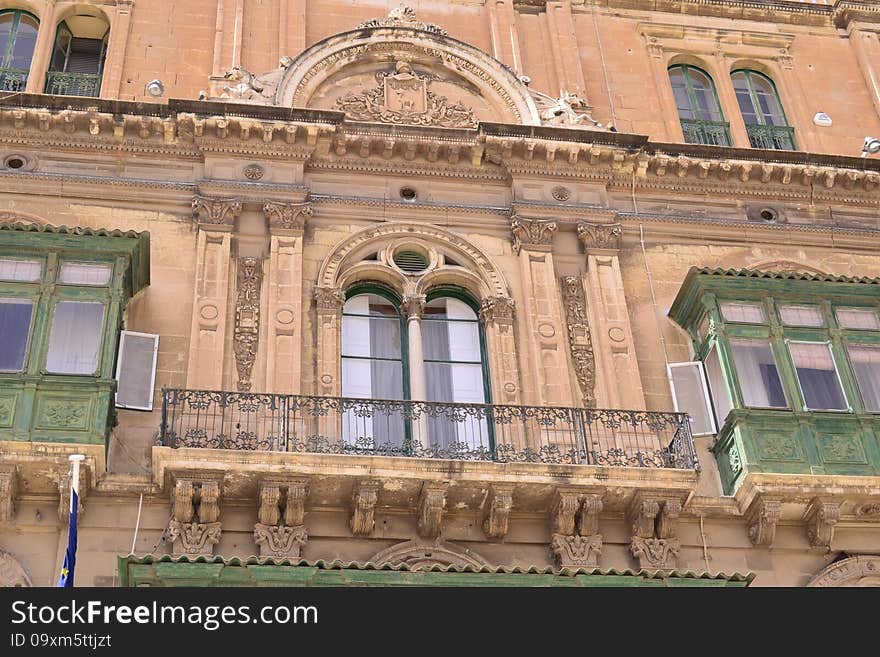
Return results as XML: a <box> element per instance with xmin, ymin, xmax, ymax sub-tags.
<box><xmin>578</xmin><ymin>222</ymin><xmax>645</xmax><ymax>410</ymax></box>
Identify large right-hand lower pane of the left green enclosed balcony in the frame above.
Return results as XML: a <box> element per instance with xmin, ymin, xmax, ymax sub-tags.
<box><xmin>46</xmin><ymin>301</ymin><xmax>104</xmax><ymax>374</ymax></box>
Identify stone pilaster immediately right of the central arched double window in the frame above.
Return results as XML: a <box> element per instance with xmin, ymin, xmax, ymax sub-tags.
<box><xmin>510</xmin><ymin>215</ymin><xmax>572</xmax><ymax>406</ymax></box>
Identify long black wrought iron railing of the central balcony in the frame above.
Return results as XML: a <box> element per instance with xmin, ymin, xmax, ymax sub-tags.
<box><xmin>159</xmin><ymin>389</ymin><xmax>699</xmax><ymax>470</ymax></box>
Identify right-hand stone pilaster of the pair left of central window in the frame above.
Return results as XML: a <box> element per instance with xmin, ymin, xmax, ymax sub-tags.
<box><xmin>263</xmin><ymin>202</ymin><xmax>312</xmax><ymax>394</ymax></box>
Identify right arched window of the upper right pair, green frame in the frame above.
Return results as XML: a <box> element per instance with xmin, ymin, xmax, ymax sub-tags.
<box><xmin>730</xmin><ymin>70</ymin><xmax>795</xmax><ymax>151</ymax></box>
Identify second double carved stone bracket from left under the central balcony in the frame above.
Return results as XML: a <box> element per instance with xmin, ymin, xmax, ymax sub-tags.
<box><xmin>254</xmin><ymin>479</ymin><xmax>309</xmax><ymax>558</ymax></box>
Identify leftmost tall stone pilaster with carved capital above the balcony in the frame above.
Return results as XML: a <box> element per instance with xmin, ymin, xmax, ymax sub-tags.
<box><xmin>186</xmin><ymin>196</ymin><xmax>241</xmax><ymax>390</ymax></box>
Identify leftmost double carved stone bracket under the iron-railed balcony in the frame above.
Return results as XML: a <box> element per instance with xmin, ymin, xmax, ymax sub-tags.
<box><xmin>168</xmin><ymin>475</ymin><xmax>222</xmax><ymax>557</ymax></box>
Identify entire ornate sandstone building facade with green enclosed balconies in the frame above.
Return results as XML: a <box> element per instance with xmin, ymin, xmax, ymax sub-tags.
<box><xmin>0</xmin><ymin>0</ymin><xmax>880</xmax><ymax>586</ymax></box>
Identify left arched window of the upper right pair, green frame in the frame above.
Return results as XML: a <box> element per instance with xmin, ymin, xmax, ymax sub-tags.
<box><xmin>669</xmin><ymin>65</ymin><xmax>730</xmax><ymax>146</ymax></box>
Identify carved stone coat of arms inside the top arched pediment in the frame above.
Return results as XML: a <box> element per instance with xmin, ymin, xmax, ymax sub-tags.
<box><xmin>336</xmin><ymin>61</ymin><xmax>477</xmax><ymax>128</ymax></box>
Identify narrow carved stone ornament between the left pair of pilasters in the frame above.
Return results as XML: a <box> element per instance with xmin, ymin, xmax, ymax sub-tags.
<box><xmin>232</xmin><ymin>258</ymin><xmax>263</xmax><ymax>392</ymax></box>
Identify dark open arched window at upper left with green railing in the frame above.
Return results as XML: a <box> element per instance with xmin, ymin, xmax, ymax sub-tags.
<box><xmin>46</xmin><ymin>15</ymin><xmax>110</xmax><ymax>97</ymax></box>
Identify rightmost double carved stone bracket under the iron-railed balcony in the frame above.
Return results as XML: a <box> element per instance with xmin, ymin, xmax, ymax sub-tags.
<box><xmin>627</xmin><ymin>493</ymin><xmax>681</xmax><ymax>570</ymax></box>
